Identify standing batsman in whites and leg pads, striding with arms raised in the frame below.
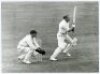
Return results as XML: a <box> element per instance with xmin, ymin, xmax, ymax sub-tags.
<box><xmin>50</xmin><ymin>15</ymin><xmax>77</xmax><ymax>61</ymax></box>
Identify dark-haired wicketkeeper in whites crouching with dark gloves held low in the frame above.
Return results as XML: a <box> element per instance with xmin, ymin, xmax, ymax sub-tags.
<box><xmin>17</xmin><ymin>30</ymin><xmax>46</xmax><ymax>64</ymax></box>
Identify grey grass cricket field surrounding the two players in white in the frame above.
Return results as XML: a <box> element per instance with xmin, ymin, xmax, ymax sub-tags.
<box><xmin>1</xmin><ymin>2</ymin><xmax>99</xmax><ymax>73</ymax></box>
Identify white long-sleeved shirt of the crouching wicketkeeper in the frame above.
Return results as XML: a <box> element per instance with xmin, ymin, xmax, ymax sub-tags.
<box><xmin>18</xmin><ymin>34</ymin><xmax>40</xmax><ymax>49</ymax></box>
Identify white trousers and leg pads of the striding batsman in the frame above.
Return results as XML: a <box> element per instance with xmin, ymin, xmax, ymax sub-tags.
<box><xmin>51</xmin><ymin>33</ymin><xmax>77</xmax><ymax>58</ymax></box>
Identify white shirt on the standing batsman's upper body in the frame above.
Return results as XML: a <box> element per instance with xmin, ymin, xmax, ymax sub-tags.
<box><xmin>58</xmin><ymin>20</ymin><xmax>69</xmax><ymax>33</ymax></box>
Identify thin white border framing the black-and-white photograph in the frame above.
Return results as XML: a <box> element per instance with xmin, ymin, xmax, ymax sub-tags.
<box><xmin>0</xmin><ymin>0</ymin><xmax>100</xmax><ymax>74</ymax></box>
